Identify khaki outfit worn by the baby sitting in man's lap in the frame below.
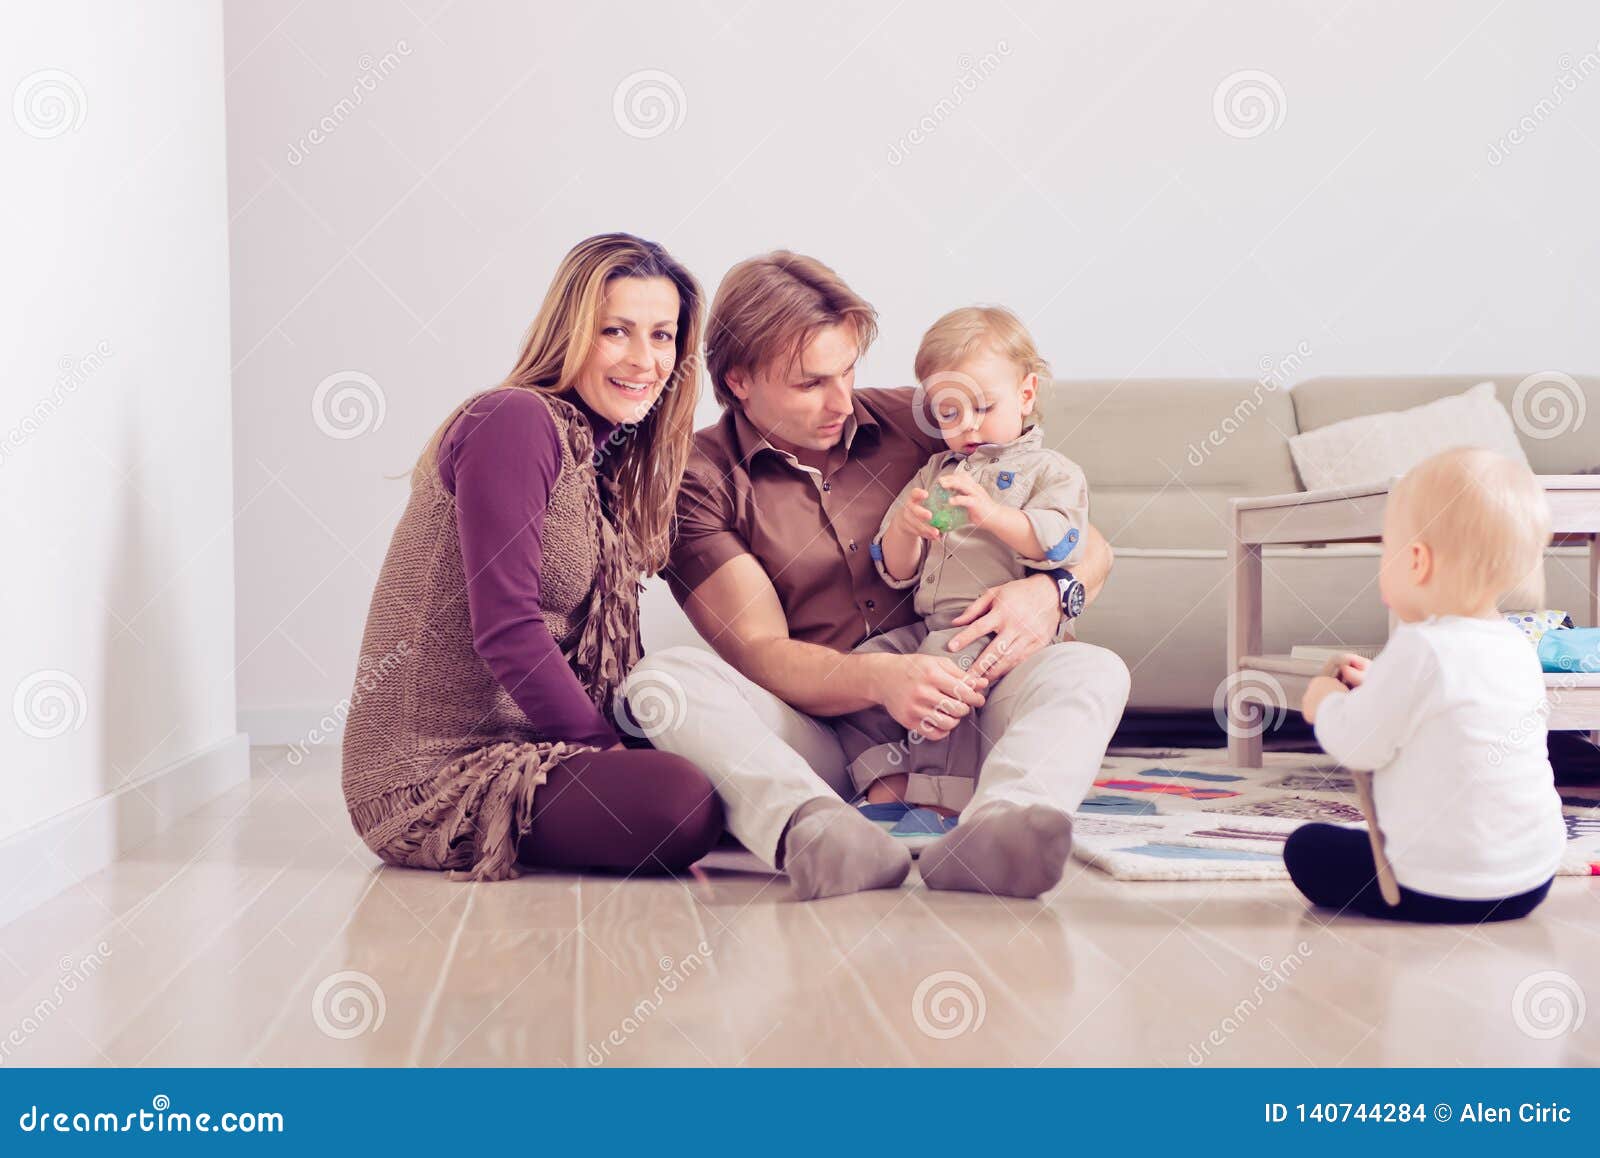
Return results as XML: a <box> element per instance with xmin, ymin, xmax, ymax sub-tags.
<box><xmin>832</xmin><ymin>425</ymin><xmax>1088</xmax><ymax>811</ymax></box>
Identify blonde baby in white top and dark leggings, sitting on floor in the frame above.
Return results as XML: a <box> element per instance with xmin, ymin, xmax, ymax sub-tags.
<box><xmin>1283</xmin><ymin>449</ymin><xmax>1566</xmax><ymax>923</ymax></box>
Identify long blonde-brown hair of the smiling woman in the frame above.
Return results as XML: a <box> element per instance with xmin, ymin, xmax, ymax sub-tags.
<box><xmin>422</xmin><ymin>234</ymin><xmax>704</xmax><ymax>574</ymax></box>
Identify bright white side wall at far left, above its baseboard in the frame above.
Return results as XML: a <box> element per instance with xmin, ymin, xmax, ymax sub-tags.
<box><xmin>0</xmin><ymin>2</ymin><xmax>246</xmax><ymax>857</ymax></box>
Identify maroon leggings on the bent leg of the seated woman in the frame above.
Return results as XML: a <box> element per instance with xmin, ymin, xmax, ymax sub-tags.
<box><xmin>517</xmin><ymin>749</ymin><xmax>722</xmax><ymax>873</ymax></box>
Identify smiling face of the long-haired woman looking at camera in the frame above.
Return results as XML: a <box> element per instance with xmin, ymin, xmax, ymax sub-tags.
<box><xmin>574</xmin><ymin>277</ymin><xmax>678</xmax><ymax>422</ymax></box>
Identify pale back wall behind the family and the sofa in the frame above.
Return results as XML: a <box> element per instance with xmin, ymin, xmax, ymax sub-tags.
<box><xmin>227</xmin><ymin>0</ymin><xmax>1600</xmax><ymax>739</ymax></box>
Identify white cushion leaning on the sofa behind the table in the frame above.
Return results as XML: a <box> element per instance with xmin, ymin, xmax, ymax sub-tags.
<box><xmin>1290</xmin><ymin>382</ymin><xmax>1528</xmax><ymax>491</ymax></box>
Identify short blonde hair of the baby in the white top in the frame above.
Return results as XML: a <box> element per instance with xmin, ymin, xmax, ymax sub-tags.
<box><xmin>1389</xmin><ymin>446</ymin><xmax>1550</xmax><ymax>611</ymax></box>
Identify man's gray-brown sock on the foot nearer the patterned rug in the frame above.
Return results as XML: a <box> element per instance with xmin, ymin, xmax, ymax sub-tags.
<box><xmin>917</xmin><ymin>803</ymin><xmax>1072</xmax><ymax>897</ymax></box>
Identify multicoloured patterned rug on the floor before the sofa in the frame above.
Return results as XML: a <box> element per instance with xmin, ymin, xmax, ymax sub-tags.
<box><xmin>1072</xmin><ymin>749</ymin><xmax>1600</xmax><ymax>881</ymax></box>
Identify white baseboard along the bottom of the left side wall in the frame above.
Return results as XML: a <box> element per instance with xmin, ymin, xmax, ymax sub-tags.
<box><xmin>0</xmin><ymin>733</ymin><xmax>250</xmax><ymax>926</ymax></box>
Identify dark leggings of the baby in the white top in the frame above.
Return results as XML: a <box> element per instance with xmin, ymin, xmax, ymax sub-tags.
<box><xmin>1283</xmin><ymin>824</ymin><xmax>1550</xmax><ymax>924</ymax></box>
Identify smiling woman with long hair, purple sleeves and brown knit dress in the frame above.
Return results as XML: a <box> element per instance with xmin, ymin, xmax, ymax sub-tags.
<box><xmin>344</xmin><ymin>234</ymin><xmax>722</xmax><ymax>881</ymax></box>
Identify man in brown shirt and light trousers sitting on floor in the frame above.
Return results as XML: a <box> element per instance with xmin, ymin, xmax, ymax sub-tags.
<box><xmin>624</xmin><ymin>251</ymin><xmax>1128</xmax><ymax>899</ymax></box>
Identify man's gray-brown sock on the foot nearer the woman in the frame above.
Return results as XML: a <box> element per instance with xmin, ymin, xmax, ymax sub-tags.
<box><xmin>782</xmin><ymin>797</ymin><xmax>910</xmax><ymax>900</ymax></box>
